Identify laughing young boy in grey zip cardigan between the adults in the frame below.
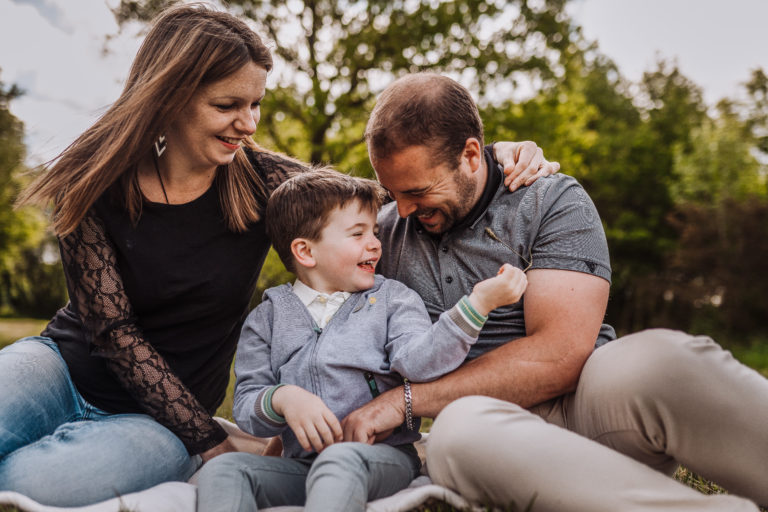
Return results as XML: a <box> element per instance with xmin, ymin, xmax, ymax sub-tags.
<box><xmin>198</xmin><ymin>170</ymin><xmax>526</xmax><ymax>512</ymax></box>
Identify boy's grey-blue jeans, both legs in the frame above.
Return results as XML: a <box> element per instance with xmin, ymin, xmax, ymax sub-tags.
<box><xmin>197</xmin><ymin>443</ymin><xmax>421</xmax><ymax>512</ymax></box>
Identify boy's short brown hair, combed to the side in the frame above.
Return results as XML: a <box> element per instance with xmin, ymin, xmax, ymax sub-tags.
<box><xmin>266</xmin><ymin>167</ymin><xmax>384</xmax><ymax>273</ymax></box>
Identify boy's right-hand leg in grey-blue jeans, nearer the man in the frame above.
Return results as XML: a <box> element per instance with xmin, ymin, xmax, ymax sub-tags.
<box><xmin>304</xmin><ymin>443</ymin><xmax>421</xmax><ymax>512</ymax></box>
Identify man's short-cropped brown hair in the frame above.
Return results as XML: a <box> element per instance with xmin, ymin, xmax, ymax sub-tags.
<box><xmin>365</xmin><ymin>73</ymin><xmax>483</xmax><ymax>168</ymax></box>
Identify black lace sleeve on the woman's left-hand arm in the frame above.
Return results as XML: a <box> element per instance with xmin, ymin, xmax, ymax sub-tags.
<box><xmin>59</xmin><ymin>213</ymin><xmax>227</xmax><ymax>455</ymax></box>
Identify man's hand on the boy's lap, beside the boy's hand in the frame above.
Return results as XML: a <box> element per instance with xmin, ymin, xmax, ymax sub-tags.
<box><xmin>341</xmin><ymin>387</ymin><xmax>405</xmax><ymax>444</ymax></box>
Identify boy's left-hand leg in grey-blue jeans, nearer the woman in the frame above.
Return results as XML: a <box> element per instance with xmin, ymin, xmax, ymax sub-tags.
<box><xmin>197</xmin><ymin>452</ymin><xmax>310</xmax><ymax>512</ymax></box>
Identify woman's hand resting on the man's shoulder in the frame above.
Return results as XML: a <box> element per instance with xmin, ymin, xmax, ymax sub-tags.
<box><xmin>493</xmin><ymin>140</ymin><xmax>560</xmax><ymax>192</ymax></box>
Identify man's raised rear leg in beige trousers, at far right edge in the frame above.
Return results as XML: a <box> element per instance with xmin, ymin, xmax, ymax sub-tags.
<box><xmin>565</xmin><ymin>329</ymin><xmax>768</xmax><ymax>504</ymax></box>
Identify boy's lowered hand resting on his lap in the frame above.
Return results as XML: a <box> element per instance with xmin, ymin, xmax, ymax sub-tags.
<box><xmin>272</xmin><ymin>385</ymin><xmax>344</xmax><ymax>453</ymax></box>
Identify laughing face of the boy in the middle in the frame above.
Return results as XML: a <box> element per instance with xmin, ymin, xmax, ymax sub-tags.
<box><xmin>300</xmin><ymin>200</ymin><xmax>381</xmax><ymax>294</ymax></box>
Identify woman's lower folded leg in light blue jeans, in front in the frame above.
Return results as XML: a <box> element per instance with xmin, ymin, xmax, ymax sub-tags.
<box><xmin>0</xmin><ymin>414</ymin><xmax>199</xmax><ymax>507</ymax></box>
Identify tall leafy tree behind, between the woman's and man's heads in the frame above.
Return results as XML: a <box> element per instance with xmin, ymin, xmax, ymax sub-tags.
<box><xmin>115</xmin><ymin>0</ymin><xmax>571</xmax><ymax>172</ymax></box>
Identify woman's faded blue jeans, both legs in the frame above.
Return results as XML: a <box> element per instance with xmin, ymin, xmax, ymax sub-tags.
<box><xmin>0</xmin><ymin>337</ymin><xmax>200</xmax><ymax>507</ymax></box>
